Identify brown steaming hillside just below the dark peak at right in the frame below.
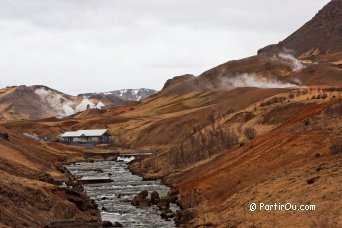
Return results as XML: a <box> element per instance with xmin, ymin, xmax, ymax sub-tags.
<box><xmin>159</xmin><ymin>51</ymin><xmax>342</xmax><ymax>96</ymax></box>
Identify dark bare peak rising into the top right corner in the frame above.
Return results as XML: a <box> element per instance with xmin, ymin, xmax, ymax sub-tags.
<box><xmin>258</xmin><ymin>0</ymin><xmax>342</xmax><ymax>56</ymax></box>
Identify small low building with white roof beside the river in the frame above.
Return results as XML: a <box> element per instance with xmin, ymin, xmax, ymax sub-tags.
<box><xmin>59</xmin><ymin>129</ymin><xmax>112</xmax><ymax>144</ymax></box>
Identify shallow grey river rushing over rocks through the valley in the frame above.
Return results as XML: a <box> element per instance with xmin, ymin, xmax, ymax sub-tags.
<box><xmin>66</xmin><ymin>156</ymin><xmax>179</xmax><ymax>227</ymax></box>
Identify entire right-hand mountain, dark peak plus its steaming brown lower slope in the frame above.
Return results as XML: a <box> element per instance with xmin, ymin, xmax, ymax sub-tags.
<box><xmin>161</xmin><ymin>0</ymin><xmax>342</xmax><ymax>95</ymax></box>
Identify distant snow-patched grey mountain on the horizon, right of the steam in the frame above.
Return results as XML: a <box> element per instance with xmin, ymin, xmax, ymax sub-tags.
<box><xmin>78</xmin><ymin>88</ymin><xmax>157</xmax><ymax>103</ymax></box>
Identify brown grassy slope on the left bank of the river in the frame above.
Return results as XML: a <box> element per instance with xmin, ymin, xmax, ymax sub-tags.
<box><xmin>0</xmin><ymin>126</ymin><xmax>101</xmax><ymax>227</ymax></box>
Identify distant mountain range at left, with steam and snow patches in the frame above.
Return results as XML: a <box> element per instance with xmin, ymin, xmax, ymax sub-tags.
<box><xmin>0</xmin><ymin>85</ymin><xmax>156</xmax><ymax>120</ymax></box>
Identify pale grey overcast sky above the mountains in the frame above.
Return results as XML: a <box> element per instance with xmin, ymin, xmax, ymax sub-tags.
<box><xmin>0</xmin><ymin>0</ymin><xmax>329</xmax><ymax>94</ymax></box>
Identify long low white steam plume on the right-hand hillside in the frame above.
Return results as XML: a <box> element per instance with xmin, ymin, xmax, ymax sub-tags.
<box><xmin>221</xmin><ymin>73</ymin><xmax>297</xmax><ymax>89</ymax></box>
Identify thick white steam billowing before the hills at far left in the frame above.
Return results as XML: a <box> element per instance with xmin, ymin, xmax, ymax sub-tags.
<box><xmin>35</xmin><ymin>88</ymin><xmax>105</xmax><ymax>118</ymax></box>
